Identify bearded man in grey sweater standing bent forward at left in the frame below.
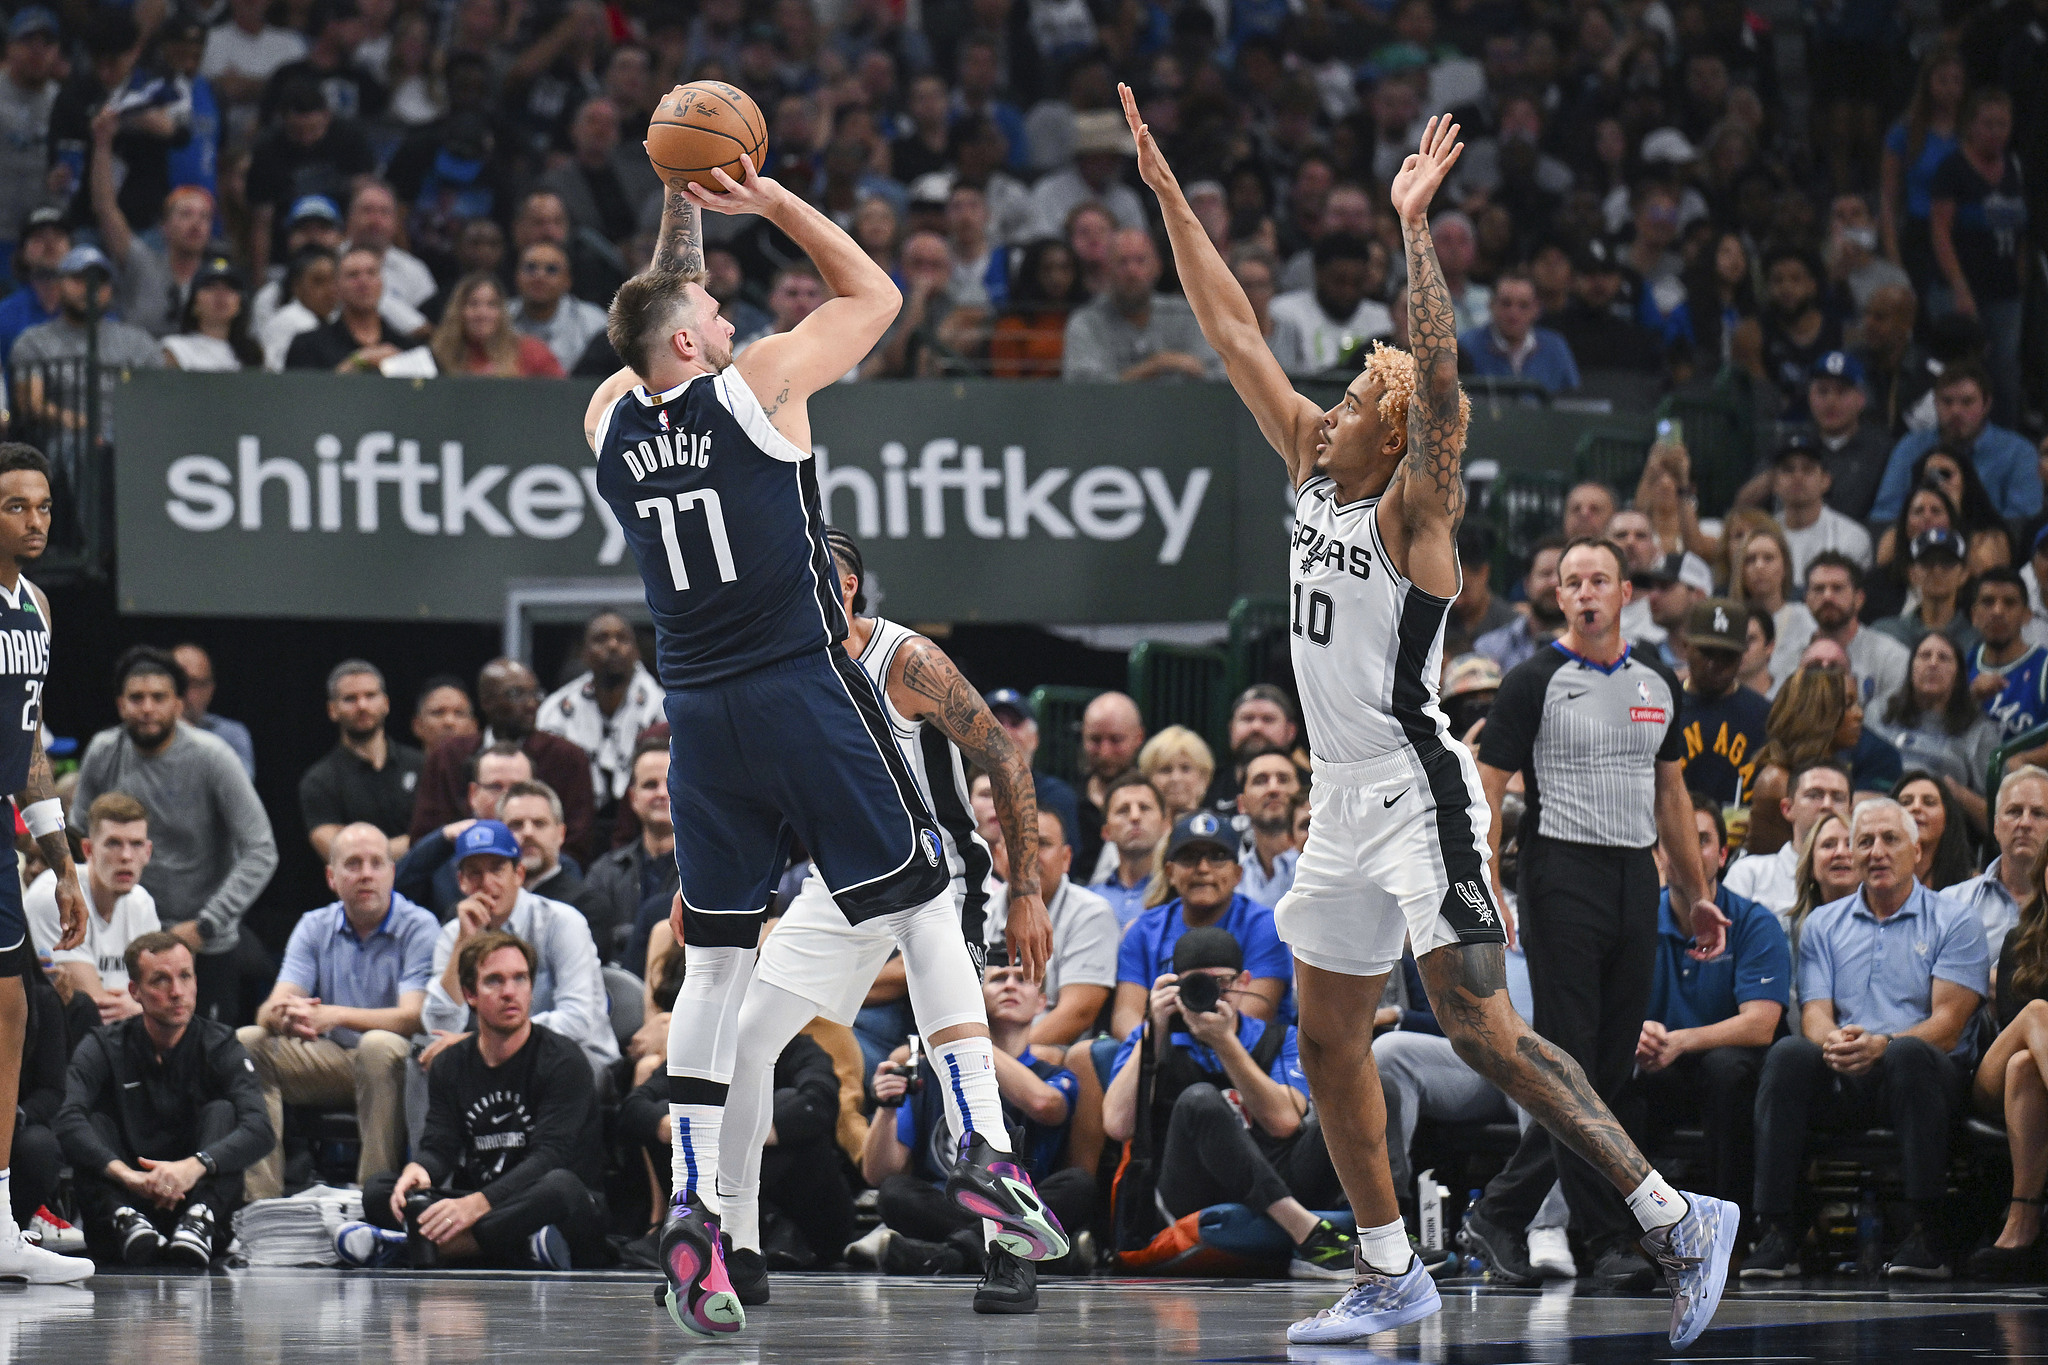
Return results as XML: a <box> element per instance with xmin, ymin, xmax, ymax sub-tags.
<box><xmin>72</xmin><ymin>645</ymin><xmax>276</xmax><ymax>1023</ymax></box>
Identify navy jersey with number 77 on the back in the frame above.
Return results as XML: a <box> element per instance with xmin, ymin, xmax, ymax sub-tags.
<box><xmin>596</xmin><ymin>366</ymin><xmax>846</xmax><ymax>692</ymax></box>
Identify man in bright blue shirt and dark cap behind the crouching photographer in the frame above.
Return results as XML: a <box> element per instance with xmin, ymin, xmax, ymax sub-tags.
<box><xmin>1110</xmin><ymin>810</ymin><xmax>1294</xmax><ymax>1038</ymax></box>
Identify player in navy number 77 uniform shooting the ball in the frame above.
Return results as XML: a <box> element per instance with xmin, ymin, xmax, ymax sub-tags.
<box><xmin>584</xmin><ymin>90</ymin><xmax>1065</xmax><ymax>1336</ymax></box>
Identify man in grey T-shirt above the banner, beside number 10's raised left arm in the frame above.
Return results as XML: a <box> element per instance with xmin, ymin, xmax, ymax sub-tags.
<box><xmin>1040</xmin><ymin>227</ymin><xmax>1223</xmax><ymax>385</ymax></box>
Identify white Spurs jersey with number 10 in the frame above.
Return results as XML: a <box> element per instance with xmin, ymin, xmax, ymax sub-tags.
<box><xmin>1288</xmin><ymin>475</ymin><xmax>1450</xmax><ymax>763</ymax></box>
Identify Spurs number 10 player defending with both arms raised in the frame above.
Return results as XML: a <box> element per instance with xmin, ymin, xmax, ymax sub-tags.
<box><xmin>1120</xmin><ymin>86</ymin><xmax>1739</xmax><ymax>1347</ymax></box>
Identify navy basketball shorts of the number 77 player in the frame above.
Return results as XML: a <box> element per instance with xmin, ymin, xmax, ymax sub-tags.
<box><xmin>666</xmin><ymin>647</ymin><xmax>952</xmax><ymax>948</ymax></box>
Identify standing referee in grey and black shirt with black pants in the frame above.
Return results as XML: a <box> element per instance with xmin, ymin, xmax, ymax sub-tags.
<box><xmin>1464</xmin><ymin>536</ymin><xmax>1726</xmax><ymax>1283</ymax></box>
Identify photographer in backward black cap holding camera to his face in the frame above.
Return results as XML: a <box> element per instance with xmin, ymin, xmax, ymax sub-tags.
<box><xmin>1102</xmin><ymin>927</ymin><xmax>1352</xmax><ymax>1279</ymax></box>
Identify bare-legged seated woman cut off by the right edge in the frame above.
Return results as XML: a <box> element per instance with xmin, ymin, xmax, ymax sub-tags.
<box><xmin>1970</xmin><ymin>857</ymin><xmax>2048</xmax><ymax>1281</ymax></box>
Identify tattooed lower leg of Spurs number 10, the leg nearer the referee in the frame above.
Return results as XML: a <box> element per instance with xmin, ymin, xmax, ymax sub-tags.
<box><xmin>1417</xmin><ymin>943</ymin><xmax>1651</xmax><ymax>1189</ymax></box>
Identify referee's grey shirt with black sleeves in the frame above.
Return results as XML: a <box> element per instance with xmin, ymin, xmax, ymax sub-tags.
<box><xmin>1479</xmin><ymin>641</ymin><xmax>1686</xmax><ymax>849</ymax></box>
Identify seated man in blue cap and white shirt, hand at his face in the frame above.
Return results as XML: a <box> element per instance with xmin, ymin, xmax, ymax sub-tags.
<box><xmin>420</xmin><ymin>821</ymin><xmax>618</xmax><ymax>1070</ymax></box>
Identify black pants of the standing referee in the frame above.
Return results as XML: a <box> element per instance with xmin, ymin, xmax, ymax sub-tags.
<box><xmin>1481</xmin><ymin>839</ymin><xmax>1659</xmax><ymax>1254</ymax></box>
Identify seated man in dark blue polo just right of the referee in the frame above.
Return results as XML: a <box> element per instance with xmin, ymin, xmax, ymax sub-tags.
<box><xmin>1616</xmin><ymin>792</ymin><xmax>1792</xmax><ymax>1227</ymax></box>
